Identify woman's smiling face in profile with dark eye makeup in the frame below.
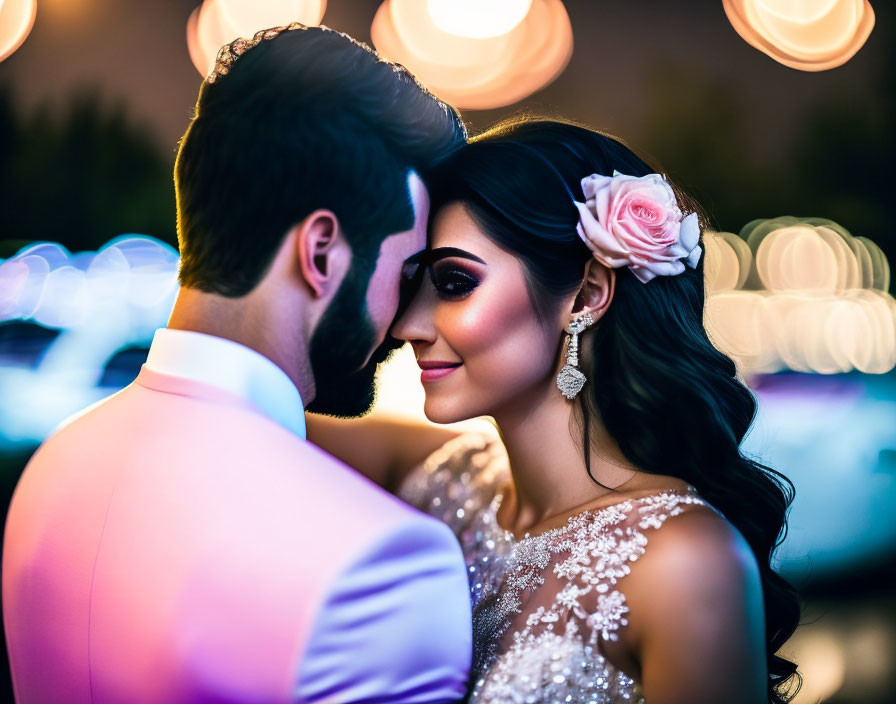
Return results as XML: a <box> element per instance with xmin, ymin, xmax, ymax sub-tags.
<box><xmin>392</xmin><ymin>203</ymin><xmax>568</xmax><ymax>423</ymax></box>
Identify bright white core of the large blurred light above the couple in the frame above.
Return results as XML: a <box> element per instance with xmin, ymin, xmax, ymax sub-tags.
<box><xmin>426</xmin><ymin>0</ymin><xmax>532</xmax><ymax>39</ymax></box>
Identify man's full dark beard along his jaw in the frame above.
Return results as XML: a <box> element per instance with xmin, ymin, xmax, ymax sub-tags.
<box><xmin>307</xmin><ymin>270</ymin><xmax>404</xmax><ymax>418</ymax></box>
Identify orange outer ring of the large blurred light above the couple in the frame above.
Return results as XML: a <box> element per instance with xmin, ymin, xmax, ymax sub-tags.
<box><xmin>370</xmin><ymin>0</ymin><xmax>572</xmax><ymax>110</ymax></box>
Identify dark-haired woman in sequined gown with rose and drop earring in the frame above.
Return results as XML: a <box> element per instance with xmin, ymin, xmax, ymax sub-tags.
<box><xmin>311</xmin><ymin>121</ymin><xmax>798</xmax><ymax>704</ymax></box>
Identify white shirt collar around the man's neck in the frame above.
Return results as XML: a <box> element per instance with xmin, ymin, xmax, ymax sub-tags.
<box><xmin>146</xmin><ymin>328</ymin><xmax>305</xmax><ymax>438</ymax></box>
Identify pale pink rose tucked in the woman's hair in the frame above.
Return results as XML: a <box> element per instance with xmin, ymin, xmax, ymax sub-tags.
<box><xmin>575</xmin><ymin>171</ymin><xmax>702</xmax><ymax>283</ymax></box>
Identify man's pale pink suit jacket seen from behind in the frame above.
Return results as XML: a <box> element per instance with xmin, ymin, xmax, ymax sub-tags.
<box><xmin>3</xmin><ymin>367</ymin><xmax>472</xmax><ymax>704</ymax></box>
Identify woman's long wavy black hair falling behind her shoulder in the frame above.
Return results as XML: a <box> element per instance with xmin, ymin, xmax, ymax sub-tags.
<box><xmin>431</xmin><ymin>118</ymin><xmax>800</xmax><ymax>704</ymax></box>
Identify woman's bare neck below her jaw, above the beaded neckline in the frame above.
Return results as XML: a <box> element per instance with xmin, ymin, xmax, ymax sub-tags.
<box><xmin>495</xmin><ymin>382</ymin><xmax>644</xmax><ymax>533</ymax></box>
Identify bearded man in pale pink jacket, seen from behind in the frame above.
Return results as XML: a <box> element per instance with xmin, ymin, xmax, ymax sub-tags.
<box><xmin>3</xmin><ymin>25</ymin><xmax>471</xmax><ymax>704</ymax></box>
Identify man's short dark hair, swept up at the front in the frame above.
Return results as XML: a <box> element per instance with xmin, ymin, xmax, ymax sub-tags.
<box><xmin>174</xmin><ymin>27</ymin><xmax>466</xmax><ymax>297</ymax></box>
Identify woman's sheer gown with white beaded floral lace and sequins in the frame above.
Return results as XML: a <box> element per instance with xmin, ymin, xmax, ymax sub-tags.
<box><xmin>399</xmin><ymin>434</ymin><xmax>706</xmax><ymax>704</ymax></box>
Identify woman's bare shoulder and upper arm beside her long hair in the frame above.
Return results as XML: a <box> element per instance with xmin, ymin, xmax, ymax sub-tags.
<box><xmin>622</xmin><ymin>505</ymin><xmax>766</xmax><ymax>701</ymax></box>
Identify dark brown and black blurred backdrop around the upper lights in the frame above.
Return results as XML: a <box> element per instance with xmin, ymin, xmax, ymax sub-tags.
<box><xmin>0</xmin><ymin>0</ymin><xmax>896</xmax><ymax>272</ymax></box>
